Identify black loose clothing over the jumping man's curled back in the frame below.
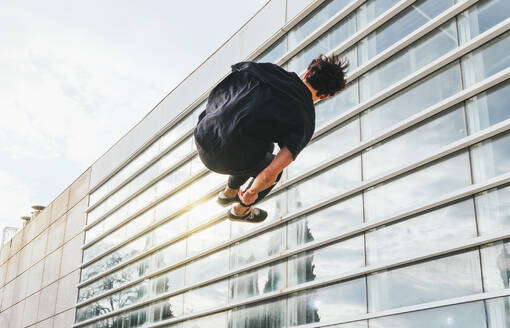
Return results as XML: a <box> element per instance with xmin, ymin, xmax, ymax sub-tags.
<box><xmin>194</xmin><ymin>62</ymin><xmax>315</xmax><ymax>175</ymax></box>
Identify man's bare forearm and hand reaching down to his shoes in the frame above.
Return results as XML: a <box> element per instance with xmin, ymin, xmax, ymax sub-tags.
<box><xmin>239</xmin><ymin>147</ymin><xmax>294</xmax><ymax>204</ymax></box>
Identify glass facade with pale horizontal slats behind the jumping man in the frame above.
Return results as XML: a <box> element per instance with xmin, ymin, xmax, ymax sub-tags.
<box><xmin>75</xmin><ymin>0</ymin><xmax>510</xmax><ymax>328</ymax></box>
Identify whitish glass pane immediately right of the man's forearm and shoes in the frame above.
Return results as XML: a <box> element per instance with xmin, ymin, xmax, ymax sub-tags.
<box><xmin>288</xmin><ymin>156</ymin><xmax>361</xmax><ymax>213</ymax></box>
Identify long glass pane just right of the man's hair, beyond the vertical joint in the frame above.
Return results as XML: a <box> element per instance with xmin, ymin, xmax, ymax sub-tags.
<box><xmin>360</xmin><ymin>19</ymin><xmax>458</xmax><ymax>102</ymax></box>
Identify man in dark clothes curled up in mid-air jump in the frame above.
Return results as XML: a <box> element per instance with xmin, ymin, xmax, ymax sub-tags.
<box><xmin>194</xmin><ymin>54</ymin><xmax>348</xmax><ymax>222</ymax></box>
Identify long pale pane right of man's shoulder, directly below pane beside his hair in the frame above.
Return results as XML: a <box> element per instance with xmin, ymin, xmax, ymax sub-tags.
<box><xmin>361</xmin><ymin>63</ymin><xmax>462</xmax><ymax>140</ymax></box>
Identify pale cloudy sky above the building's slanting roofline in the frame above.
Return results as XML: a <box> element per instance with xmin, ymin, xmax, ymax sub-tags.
<box><xmin>0</xmin><ymin>0</ymin><xmax>267</xmax><ymax>233</ymax></box>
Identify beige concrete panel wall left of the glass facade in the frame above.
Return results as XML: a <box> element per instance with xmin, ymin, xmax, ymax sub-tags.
<box><xmin>0</xmin><ymin>169</ymin><xmax>90</xmax><ymax>328</ymax></box>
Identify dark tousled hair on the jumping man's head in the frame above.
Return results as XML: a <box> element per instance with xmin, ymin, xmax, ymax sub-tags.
<box><xmin>306</xmin><ymin>54</ymin><xmax>349</xmax><ymax>96</ymax></box>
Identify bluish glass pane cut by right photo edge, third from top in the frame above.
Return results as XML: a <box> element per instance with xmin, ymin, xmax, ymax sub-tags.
<box><xmin>466</xmin><ymin>81</ymin><xmax>510</xmax><ymax>133</ymax></box>
